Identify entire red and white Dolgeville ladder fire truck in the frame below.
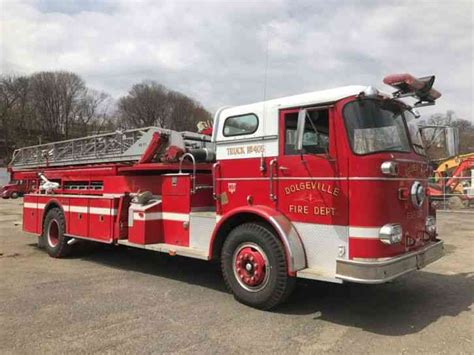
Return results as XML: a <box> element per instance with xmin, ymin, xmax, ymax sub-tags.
<box><xmin>11</xmin><ymin>75</ymin><xmax>443</xmax><ymax>309</ymax></box>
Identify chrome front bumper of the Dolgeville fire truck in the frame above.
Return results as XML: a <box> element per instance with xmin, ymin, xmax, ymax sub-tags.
<box><xmin>336</xmin><ymin>240</ymin><xmax>444</xmax><ymax>284</ymax></box>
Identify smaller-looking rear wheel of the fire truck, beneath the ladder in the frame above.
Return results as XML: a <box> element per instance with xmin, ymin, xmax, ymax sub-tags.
<box><xmin>40</xmin><ymin>208</ymin><xmax>71</xmax><ymax>258</ymax></box>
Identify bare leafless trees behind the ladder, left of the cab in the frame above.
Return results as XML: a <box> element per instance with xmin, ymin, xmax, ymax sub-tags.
<box><xmin>0</xmin><ymin>71</ymin><xmax>211</xmax><ymax>164</ymax></box>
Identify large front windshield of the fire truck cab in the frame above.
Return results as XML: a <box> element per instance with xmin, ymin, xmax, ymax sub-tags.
<box><xmin>344</xmin><ymin>99</ymin><xmax>411</xmax><ymax>154</ymax></box>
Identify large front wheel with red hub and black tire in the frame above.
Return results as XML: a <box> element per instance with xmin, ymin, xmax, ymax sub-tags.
<box><xmin>221</xmin><ymin>223</ymin><xmax>295</xmax><ymax>310</ymax></box>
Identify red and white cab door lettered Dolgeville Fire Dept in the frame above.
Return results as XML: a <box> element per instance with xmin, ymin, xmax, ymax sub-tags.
<box><xmin>273</xmin><ymin>106</ymin><xmax>348</xmax><ymax>274</ymax></box>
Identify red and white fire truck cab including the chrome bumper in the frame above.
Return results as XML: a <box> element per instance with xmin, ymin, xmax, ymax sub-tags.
<box><xmin>213</xmin><ymin>86</ymin><xmax>442</xmax><ymax>283</ymax></box>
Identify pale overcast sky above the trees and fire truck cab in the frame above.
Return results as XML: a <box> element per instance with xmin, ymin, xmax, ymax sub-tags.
<box><xmin>0</xmin><ymin>0</ymin><xmax>474</xmax><ymax>119</ymax></box>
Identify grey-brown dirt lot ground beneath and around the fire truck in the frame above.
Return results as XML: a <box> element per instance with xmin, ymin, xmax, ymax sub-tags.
<box><xmin>0</xmin><ymin>200</ymin><xmax>474</xmax><ymax>354</ymax></box>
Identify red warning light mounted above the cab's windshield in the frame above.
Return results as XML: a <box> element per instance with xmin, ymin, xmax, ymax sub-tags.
<box><xmin>383</xmin><ymin>74</ymin><xmax>441</xmax><ymax>107</ymax></box>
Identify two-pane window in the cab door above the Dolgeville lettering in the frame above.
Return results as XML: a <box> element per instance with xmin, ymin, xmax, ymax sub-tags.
<box><xmin>285</xmin><ymin>109</ymin><xmax>329</xmax><ymax>155</ymax></box>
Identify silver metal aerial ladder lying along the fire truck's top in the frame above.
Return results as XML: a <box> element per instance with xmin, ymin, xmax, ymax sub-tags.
<box><xmin>9</xmin><ymin>127</ymin><xmax>212</xmax><ymax>171</ymax></box>
